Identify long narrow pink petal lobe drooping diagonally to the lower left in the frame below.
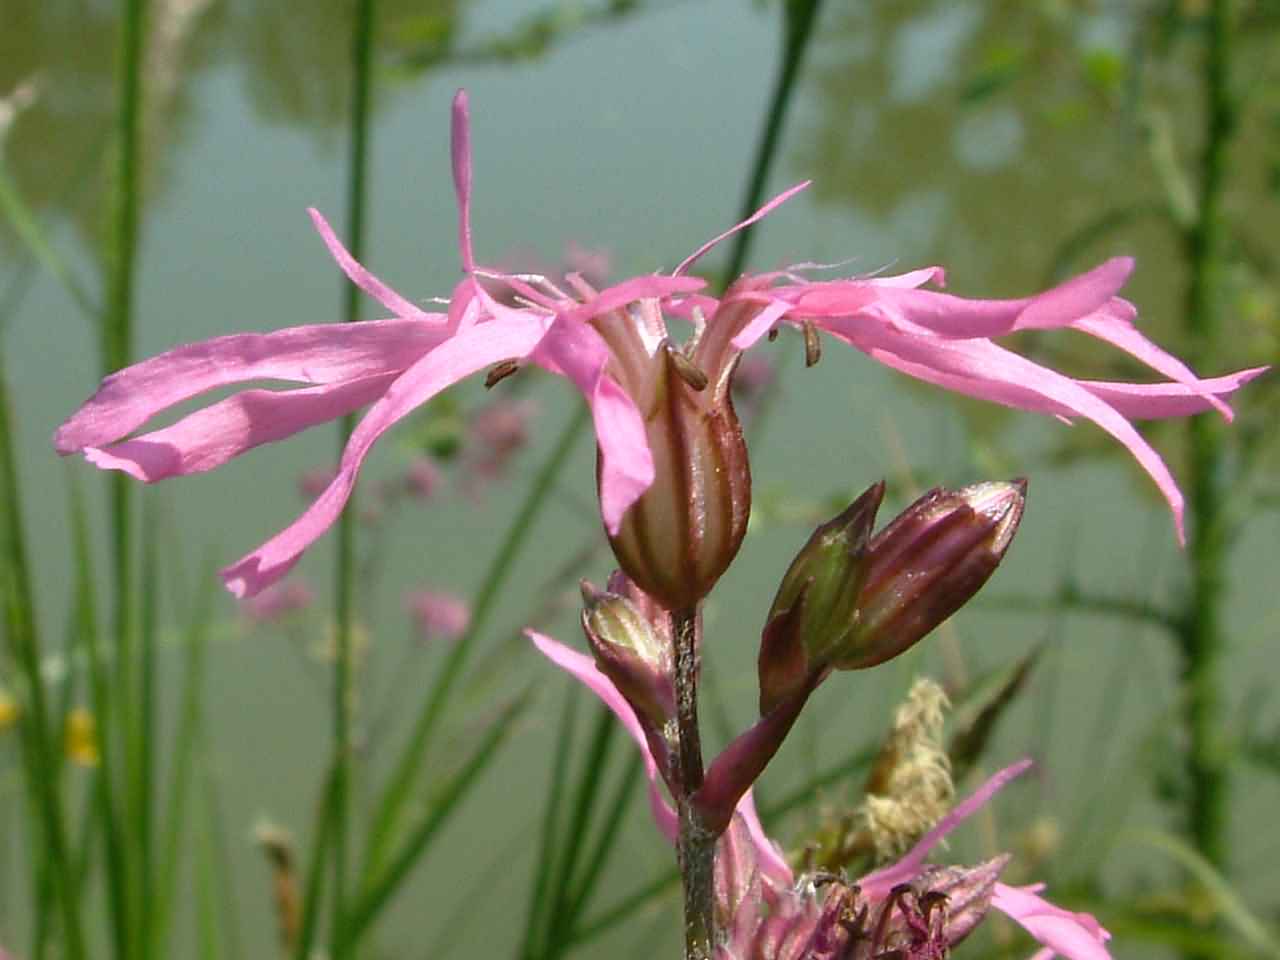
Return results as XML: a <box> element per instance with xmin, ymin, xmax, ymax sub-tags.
<box><xmin>221</xmin><ymin>317</ymin><xmax>544</xmax><ymax>596</ymax></box>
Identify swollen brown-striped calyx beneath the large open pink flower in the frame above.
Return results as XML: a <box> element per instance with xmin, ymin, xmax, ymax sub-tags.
<box><xmin>609</xmin><ymin>343</ymin><xmax>751</xmax><ymax>609</ymax></box>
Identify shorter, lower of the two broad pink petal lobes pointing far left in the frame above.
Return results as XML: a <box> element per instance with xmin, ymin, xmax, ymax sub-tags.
<box><xmin>84</xmin><ymin>374</ymin><xmax>397</xmax><ymax>484</ymax></box>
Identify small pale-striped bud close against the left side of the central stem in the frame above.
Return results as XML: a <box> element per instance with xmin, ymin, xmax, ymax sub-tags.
<box><xmin>582</xmin><ymin>575</ymin><xmax>676</xmax><ymax>731</ymax></box>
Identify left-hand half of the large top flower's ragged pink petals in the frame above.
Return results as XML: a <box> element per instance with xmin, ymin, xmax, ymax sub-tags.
<box><xmin>54</xmin><ymin>92</ymin><xmax>665</xmax><ymax>596</ymax></box>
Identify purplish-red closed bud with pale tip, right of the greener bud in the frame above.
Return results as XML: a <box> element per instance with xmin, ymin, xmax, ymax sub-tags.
<box><xmin>833</xmin><ymin>480</ymin><xmax>1027</xmax><ymax>669</ymax></box>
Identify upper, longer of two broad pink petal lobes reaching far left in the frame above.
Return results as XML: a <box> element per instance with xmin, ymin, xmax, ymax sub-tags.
<box><xmin>54</xmin><ymin>320</ymin><xmax>444</xmax><ymax>454</ymax></box>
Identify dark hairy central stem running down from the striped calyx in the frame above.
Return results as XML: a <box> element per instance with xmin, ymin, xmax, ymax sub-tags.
<box><xmin>671</xmin><ymin>607</ymin><xmax>716</xmax><ymax>960</ymax></box>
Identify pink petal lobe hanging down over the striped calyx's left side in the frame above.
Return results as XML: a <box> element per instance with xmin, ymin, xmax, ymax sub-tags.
<box><xmin>531</xmin><ymin>317</ymin><xmax>654</xmax><ymax>534</ymax></box>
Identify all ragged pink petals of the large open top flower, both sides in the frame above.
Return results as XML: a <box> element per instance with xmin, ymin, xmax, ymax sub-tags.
<box><xmin>54</xmin><ymin>92</ymin><xmax>1262</xmax><ymax>595</ymax></box>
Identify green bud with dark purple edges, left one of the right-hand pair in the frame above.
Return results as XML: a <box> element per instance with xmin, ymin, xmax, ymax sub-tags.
<box><xmin>758</xmin><ymin>483</ymin><xmax>884</xmax><ymax>713</ymax></box>
